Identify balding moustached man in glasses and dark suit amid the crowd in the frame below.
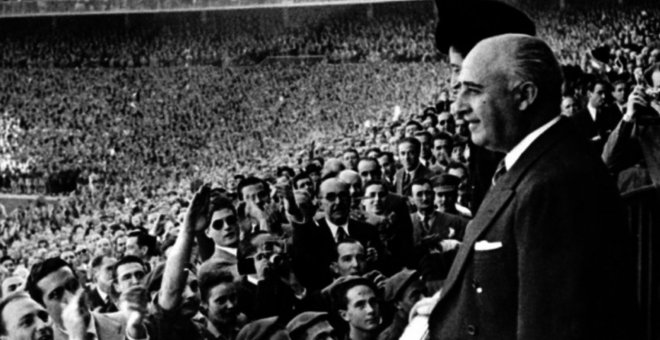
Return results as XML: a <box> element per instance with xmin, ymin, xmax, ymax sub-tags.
<box><xmin>291</xmin><ymin>177</ymin><xmax>382</xmax><ymax>289</ymax></box>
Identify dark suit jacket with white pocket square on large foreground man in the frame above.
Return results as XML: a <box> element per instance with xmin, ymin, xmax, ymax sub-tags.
<box><xmin>429</xmin><ymin>119</ymin><xmax>637</xmax><ymax>340</ymax></box>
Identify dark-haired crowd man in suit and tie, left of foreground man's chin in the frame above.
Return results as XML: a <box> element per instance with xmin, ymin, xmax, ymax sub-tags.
<box><xmin>394</xmin><ymin>137</ymin><xmax>434</xmax><ymax>197</ymax></box>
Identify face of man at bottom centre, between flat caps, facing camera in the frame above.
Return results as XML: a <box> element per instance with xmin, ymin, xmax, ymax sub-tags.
<box><xmin>340</xmin><ymin>285</ymin><xmax>380</xmax><ymax>332</ymax></box>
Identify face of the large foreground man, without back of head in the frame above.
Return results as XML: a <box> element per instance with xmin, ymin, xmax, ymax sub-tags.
<box><xmin>456</xmin><ymin>42</ymin><xmax>520</xmax><ymax>152</ymax></box>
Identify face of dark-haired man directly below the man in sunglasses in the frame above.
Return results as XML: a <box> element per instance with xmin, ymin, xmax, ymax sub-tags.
<box><xmin>205</xmin><ymin>282</ymin><xmax>238</xmax><ymax>326</ymax></box>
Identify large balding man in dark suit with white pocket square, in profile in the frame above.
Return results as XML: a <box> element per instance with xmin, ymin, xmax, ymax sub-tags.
<box><xmin>428</xmin><ymin>34</ymin><xmax>635</xmax><ymax>339</ymax></box>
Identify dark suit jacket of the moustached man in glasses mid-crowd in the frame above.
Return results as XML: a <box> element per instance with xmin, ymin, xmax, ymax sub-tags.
<box><xmin>291</xmin><ymin>218</ymin><xmax>383</xmax><ymax>290</ymax></box>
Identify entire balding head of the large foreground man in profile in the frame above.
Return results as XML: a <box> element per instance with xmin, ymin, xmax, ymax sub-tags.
<box><xmin>457</xmin><ymin>34</ymin><xmax>562</xmax><ymax>152</ymax></box>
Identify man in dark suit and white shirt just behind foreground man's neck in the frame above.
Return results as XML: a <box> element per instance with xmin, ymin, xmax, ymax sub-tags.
<box><xmin>571</xmin><ymin>78</ymin><xmax>621</xmax><ymax>155</ymax></box>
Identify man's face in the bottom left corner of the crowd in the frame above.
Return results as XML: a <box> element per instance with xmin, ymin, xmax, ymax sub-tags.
<box><xmin>2</xmin><ymin>297</ymin><xmax>53</xmax><ymax>340</ymax></box>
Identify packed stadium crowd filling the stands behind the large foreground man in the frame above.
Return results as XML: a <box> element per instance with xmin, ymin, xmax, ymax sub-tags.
<box><xmin>0</xmin><ymin>1</ymin><xmax>660</xmax><ymax>340</ymax></box>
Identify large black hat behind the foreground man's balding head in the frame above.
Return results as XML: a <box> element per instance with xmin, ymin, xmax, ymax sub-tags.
<box><xmin>435</xmin><ymin>0</ymin><xmax>536</xmax><ymax>54</ymax></box>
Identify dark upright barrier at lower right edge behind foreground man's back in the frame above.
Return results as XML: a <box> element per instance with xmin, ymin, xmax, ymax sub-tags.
<box><xmin>623</xmin><ymin>186</ymin><xmax>660</xmax><ymax>340</ymax></box>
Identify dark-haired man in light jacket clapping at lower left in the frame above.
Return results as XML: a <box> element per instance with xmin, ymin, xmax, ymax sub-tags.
<box><xmin>25</xmin><ymin>257</ymin><xmax>142</xmax><ymax>340</ymax></box>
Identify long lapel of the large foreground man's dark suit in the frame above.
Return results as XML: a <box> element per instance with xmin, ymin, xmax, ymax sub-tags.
<box><xmin>441</xmin><ymin>118</ymin><xmax>569</xmax><ymax>299</ymax></box>
